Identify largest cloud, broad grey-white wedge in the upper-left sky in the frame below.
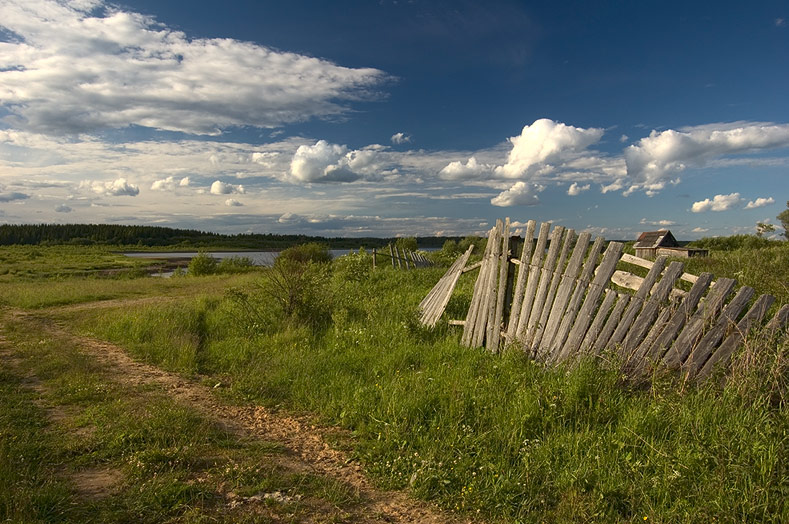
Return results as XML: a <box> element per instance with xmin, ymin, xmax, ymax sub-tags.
<box><xmin>0</xmin><ymin>0</ymin><xmax>386</xmax><ymax>135</ymax></box>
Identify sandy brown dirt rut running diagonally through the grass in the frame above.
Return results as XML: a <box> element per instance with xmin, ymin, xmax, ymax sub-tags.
<box><xmin>6</xmin><ymin>308</ymin><xmax>471</xmax><ymax>524</ymax></box>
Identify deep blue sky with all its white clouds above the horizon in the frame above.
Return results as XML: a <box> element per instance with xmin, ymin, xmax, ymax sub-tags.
<box><xmin>0</xmin><ymin>0</ymin><xmax>789</xmax><ymax>239</ymax></box>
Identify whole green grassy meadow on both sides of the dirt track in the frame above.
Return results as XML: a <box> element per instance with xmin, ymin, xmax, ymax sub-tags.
<box><xmin>0</xmin><ymin>242</ymin><xmax>789</xmax><ymax>523</ymax></box>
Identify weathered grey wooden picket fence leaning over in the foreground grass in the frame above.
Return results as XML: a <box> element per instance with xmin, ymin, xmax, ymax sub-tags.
<box><xmin>420</xmin><ymin>219</ymin><xmax>789</xmax><ymax>381</ymax></box>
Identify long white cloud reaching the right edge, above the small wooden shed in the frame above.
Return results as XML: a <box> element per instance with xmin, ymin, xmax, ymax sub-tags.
<box><xmin>625</xmin><ymin>122</ymin><xmax>789</xmax><ymax>192</ymax></box>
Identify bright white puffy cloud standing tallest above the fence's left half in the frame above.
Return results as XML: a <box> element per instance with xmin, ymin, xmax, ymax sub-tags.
<box><xmin>496</xmin><ymin>118</ymin><xmax>603</xmax><ymax>178</ymax></box>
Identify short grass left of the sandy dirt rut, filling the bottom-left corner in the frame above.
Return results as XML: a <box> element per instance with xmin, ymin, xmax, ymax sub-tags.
<box><xmin>0</xmin><ymin>319</ymin><xmax>366</xmax><ymax>523</ymax></box>
